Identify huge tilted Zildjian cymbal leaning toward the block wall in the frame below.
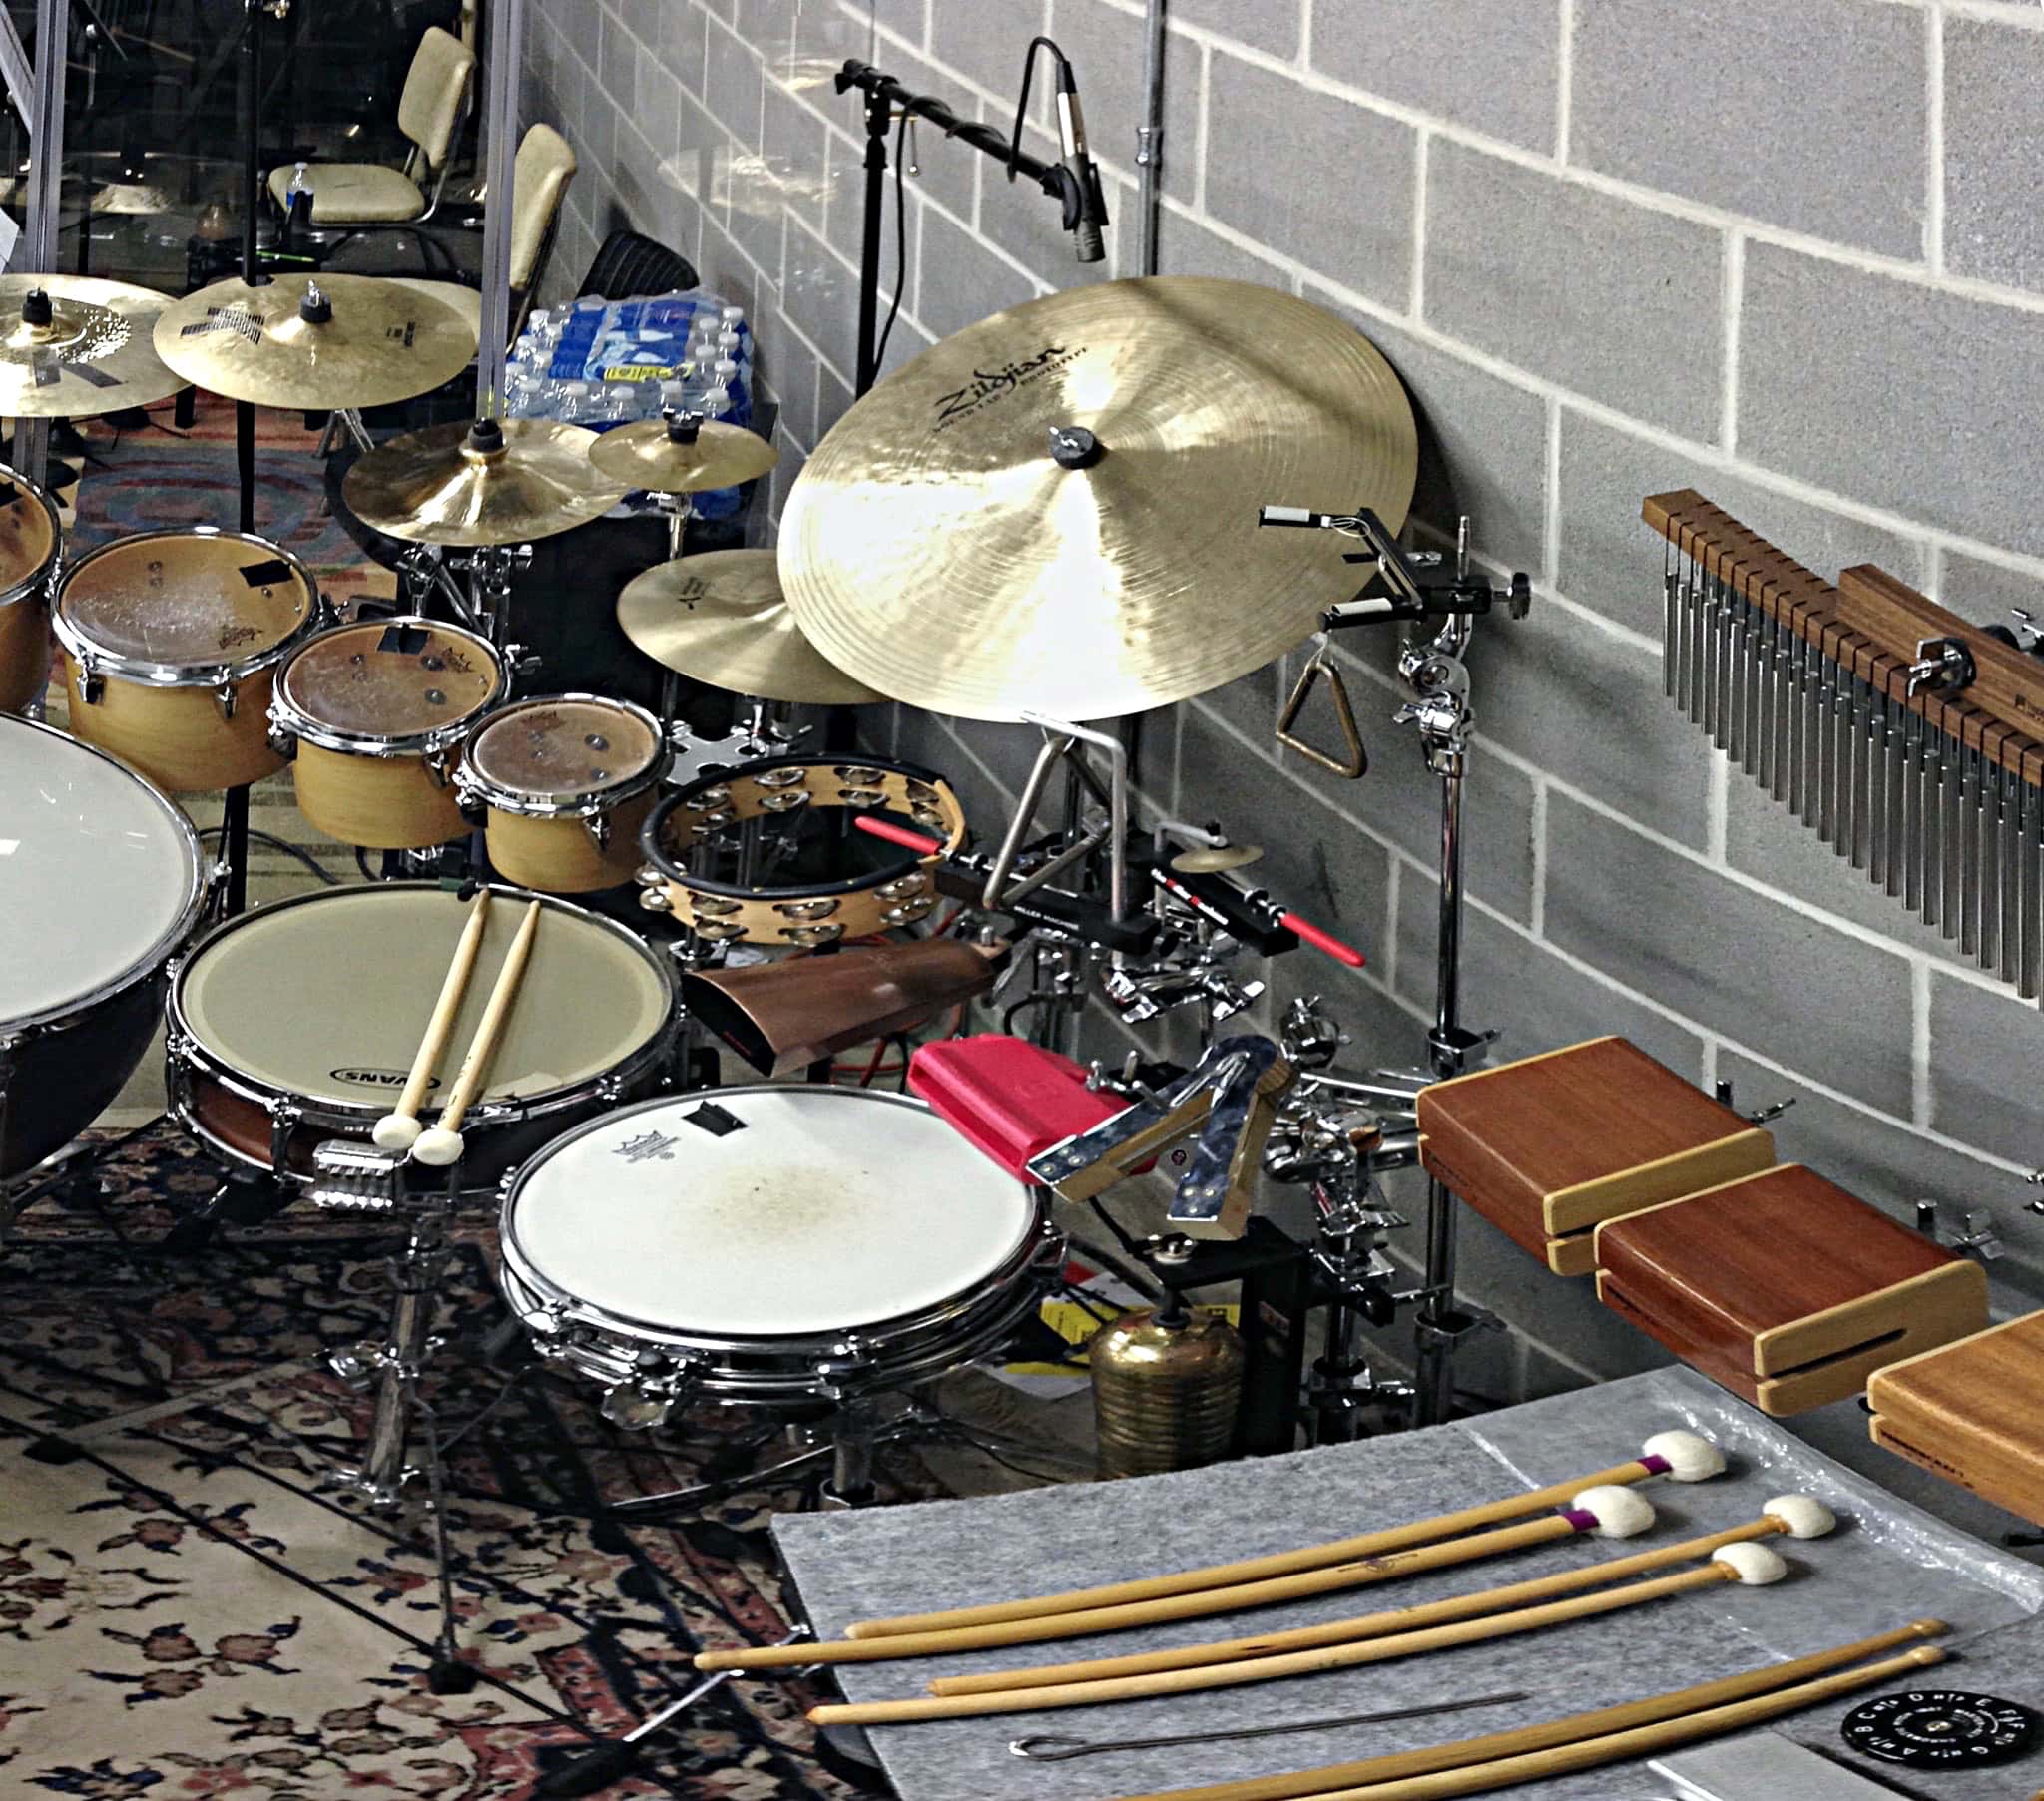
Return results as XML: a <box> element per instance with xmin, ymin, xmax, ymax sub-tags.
<box><xmin>780</xmin><ymin>276</ymin><xmax>1418</xmax><ymax>719</ymax></box>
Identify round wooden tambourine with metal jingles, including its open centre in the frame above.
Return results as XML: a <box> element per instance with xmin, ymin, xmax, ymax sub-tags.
<box><xmin>638</xmin><ymin>756</ymin><xmax>965</xmax><ymax>947</ymax></box>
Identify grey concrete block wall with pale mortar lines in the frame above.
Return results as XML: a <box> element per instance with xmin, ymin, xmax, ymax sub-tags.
<box><xmin>525</xmin><ymin>0</ymin><xmax>2044</xmax><ymax>1422</ymax></box>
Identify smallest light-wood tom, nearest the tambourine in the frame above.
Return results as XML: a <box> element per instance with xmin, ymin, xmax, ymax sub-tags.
<box><xmin>456</xmin><ymin>695</ymin><xmax>669</xmax><ymax>893</ymax></box>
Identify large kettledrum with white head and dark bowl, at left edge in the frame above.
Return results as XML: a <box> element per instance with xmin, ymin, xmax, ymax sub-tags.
<box><xmin>0</xmin><ymin>717</ymin><xmax>203</xmax><ymax>1177</ymax></box>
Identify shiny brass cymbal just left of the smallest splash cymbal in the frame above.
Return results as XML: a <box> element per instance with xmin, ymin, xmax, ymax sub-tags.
<box><xmin>341</xmin><ymin>416</ymin><xmax>626</xmax><ymax>546</ymax></box>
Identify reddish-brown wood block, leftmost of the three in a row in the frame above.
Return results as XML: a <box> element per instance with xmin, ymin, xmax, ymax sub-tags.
<box><xmin>1418</xmin><ymin>1039</ymin><xmax>1775</xmax><ymax>1275</ymax></box>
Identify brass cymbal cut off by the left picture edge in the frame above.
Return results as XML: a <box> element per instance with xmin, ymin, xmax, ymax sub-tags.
<box><xmin>0</xmin><ymin>276</ymin><xmax>186</xmax><ymax>419</ymax></box>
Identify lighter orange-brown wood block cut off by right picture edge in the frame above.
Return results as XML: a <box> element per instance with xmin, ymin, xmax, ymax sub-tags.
<box><xmin>1866</xmin><ymin>1312</ymin><xmax>2044</xmax><ymax>1525</ymax></box>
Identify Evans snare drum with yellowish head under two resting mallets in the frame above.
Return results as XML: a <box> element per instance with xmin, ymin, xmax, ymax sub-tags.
<box><xmin>166</xmin><ymin>881</ymin><xmax>675</xmax><ymax>1185</ymax></box>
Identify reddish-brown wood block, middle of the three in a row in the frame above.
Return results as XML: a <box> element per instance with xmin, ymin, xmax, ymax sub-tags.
<box><xmin>1596</xmin><ymin>1163</ymin><xmax>1987</xmax><ymax>1415</ymax></box>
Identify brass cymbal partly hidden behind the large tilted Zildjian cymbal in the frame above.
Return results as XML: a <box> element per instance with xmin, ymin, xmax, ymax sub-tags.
<box><xmin>613</xmin><ymin>552</ymin><xmax>883</xmax><ymax>707</ymax></box>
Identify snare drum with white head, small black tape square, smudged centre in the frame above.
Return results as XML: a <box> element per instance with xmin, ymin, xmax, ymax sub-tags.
<box><xmin>501</xmin><ymin>1084</ymin><xmax>1063</xmax><ymax>1425</ymax></box>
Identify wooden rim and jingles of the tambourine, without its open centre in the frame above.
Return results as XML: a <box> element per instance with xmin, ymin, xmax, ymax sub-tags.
<box><xmin>640</xmin><ymin>756</ymin><xmax>965</xmax><ymax>947</ymax></box>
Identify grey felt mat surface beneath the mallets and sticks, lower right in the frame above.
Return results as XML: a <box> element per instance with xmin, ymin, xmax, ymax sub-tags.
<box><xmin>774</xmin><ymin>1370</ymin><xmax>2044</xmax><ymax>1801</ymax></box>
